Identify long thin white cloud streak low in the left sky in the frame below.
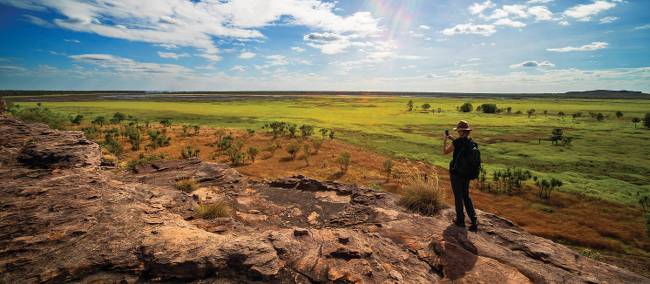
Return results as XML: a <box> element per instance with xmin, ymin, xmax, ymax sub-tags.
<box><xmin>70</xmin><ymin>54</ymin><xmax>192</xmax><ymax>74</ymax></box>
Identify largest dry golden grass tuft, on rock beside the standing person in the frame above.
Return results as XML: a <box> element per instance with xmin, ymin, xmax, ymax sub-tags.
<box><xmin>399</xmin><ymin>168</ymin><xmax>445</xmax><ymax>216</ymax></box>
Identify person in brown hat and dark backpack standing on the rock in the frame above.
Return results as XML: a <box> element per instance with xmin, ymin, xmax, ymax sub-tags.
<box><xmin>442</xmin><ymin>120</ymin><xmax>481</xmax><ymax>232</ymax></box>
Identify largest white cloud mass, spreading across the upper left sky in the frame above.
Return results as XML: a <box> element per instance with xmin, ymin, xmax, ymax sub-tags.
<box><xmin>0</xmin><ymin>0</ymin><xmax>381</xmax><ymax>61</ymax></box>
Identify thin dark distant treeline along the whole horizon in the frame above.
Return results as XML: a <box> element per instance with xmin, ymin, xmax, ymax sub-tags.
<box><xmin>0</xmin><ymin>90</ymin><xmax>650</xmax><ymax>99</ymax></box>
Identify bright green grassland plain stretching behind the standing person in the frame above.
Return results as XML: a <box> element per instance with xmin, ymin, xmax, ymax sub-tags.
<box><xmin>20</xmin><ymin>96</ymin><xmax>650</xmax><ymax>204</ymax></box>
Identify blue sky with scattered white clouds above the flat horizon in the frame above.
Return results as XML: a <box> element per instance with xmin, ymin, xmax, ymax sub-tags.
<box><xmin>0</xmin><ymin>0</ymin><xmax>650</xmax><ymax>92</ymax></box>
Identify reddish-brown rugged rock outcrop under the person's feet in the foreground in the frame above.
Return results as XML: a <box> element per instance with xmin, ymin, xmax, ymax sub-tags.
<box><xmin>0</xmin><ymin>116</ymin><xmax>650</xmax><ymax>283</ymax></box>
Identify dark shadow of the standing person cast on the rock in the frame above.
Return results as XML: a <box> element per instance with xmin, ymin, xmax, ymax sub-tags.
<box><xmin>441</xmin><ymin>224</ymin><xmax>478</xmax><ymax>281</ymax></box>
